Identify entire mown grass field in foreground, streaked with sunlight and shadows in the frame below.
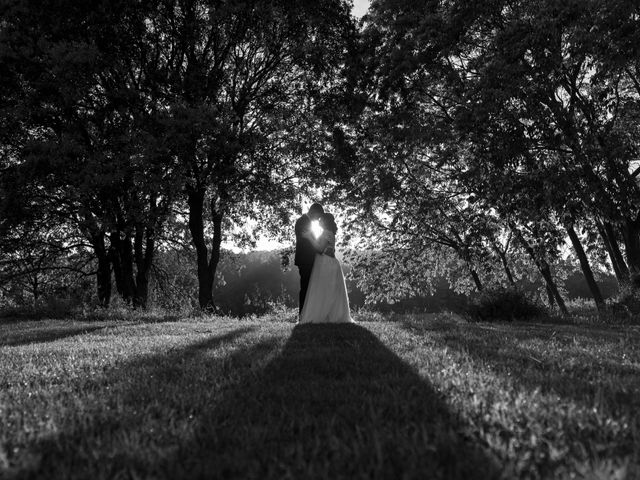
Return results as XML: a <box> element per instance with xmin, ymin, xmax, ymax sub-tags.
<box><xmin>0</xmin><ymin>314</ymin><xmax>640</xmax><ymax>480</ymax></box>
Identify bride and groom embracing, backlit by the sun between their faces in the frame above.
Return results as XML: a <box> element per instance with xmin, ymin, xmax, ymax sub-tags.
<box><xmin>295</xmin><ymin>203</ymin><xmax>353</xmax><ymax>323</ymax></box>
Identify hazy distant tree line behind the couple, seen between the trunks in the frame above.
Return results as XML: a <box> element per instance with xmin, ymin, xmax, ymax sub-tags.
<box><xmin>132</xmin><ymin>250</ymin><xmax>617</xmax><ymax>316</ymax></box>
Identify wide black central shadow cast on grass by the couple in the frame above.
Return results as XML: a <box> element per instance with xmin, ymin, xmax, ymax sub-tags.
<box><xmin>162</xmin><ymin>324</ymin><xmax>496</xmax><ymax>479</ymax></box>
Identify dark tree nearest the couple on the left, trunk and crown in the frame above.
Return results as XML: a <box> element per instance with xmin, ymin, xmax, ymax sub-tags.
<box><xmin>136</xmin><ymin>0</ymin><xmax>352</xmax><ymax>309</ymax></box>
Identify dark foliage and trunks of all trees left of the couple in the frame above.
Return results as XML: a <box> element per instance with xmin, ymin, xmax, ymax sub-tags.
<box><xmin>0</xmin><ymin>0</ymin><xmax>353</xmax><ymax>308</ymax></box>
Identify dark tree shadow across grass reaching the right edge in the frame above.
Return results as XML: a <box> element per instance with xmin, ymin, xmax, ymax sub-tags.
<box><xmin>403</xmin><ymin>319</ymin><xmax>640</xmax><ymax>414</ymax></box>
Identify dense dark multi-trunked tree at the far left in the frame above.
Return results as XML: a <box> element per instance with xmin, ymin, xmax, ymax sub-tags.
<box><xmin>2</xmin><ymin>1</ymin><xmax>182</xmax><ymax>306</ymax></box>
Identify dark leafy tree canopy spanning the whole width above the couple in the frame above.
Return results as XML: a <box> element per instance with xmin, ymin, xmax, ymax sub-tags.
<box><xmin>0</xmin><ymin>0</ymin><xmax>640</xmax><ymax>311</ymax></box>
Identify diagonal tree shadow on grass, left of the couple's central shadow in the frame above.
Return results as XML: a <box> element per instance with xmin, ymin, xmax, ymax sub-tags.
<box><xmin>14</xmin><ymin>327</ymin><xmax>264</xmax><ymax>479</ymax></box>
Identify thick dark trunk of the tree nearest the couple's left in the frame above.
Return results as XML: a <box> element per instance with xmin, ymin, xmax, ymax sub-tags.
<box><xmin>187</xmin><ymin>189</ymin><xmax>220</xmax><ymax>311</ymax></box>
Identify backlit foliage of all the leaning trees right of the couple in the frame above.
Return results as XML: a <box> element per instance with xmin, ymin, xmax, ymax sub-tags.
<box><xmin>332</xmin><ymin>0</ymin><xmax>640</xmax><ymax>311</ymax></box>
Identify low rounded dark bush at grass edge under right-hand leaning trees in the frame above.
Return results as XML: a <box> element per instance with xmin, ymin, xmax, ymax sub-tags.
<box><xmin>468</xmin><ymin>289</ymin><xmax>547</xmax><ymax>322</ymax></box>
